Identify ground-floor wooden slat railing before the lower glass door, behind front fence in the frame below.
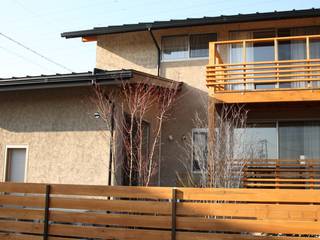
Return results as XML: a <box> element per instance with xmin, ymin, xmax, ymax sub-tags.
<box><xmin>243</xmin><ymin>159</ymin><xmax>320</xmax><ymax>189</ymax></box>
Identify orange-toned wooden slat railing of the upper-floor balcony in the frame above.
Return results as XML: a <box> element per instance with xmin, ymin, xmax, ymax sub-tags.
<box><xmin>207</xmin><ymin>35</ymin><xmax>320</xmax><ymax>93</ymax></box>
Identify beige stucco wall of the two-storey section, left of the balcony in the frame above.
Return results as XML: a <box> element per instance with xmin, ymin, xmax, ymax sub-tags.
<box><xmin>97</xmin><ymin>32</ymin><xmax>207</xmax><ymax>185</ymax></box>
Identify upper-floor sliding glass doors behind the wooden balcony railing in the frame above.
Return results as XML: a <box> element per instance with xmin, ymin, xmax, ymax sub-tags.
<box><xmin>228</xmin><ymin>26</ymin><xmax>320</xmax><ymax>90</ymax></box>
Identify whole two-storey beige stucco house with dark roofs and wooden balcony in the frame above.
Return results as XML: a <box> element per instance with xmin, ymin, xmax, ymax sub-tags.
<box><xmin>0</xmin><ymin>9</ymin><xmax>320</xmax><ymax>186</ymax></box>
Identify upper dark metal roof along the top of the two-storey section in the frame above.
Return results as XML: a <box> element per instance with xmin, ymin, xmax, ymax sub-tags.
<box><xmin>61</xmin><ymin>8</ymin><xmax>320</xmax><ymax>38</ymax></box>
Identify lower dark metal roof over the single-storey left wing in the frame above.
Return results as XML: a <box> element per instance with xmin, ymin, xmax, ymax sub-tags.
<box><xmin>0</xmin><ymin>69</ymin><xmax>180</xmax><ymax>92</ymax></box>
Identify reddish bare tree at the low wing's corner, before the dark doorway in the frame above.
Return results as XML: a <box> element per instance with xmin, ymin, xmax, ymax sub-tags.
<box><xmin>93</xmin><ymin>79</ymin><xmax>179</xmax><ymax>186</ymax></box>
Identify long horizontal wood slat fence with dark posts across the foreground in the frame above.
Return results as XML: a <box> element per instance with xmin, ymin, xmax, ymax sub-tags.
<box><xmin>0</xmin><ymin>183</ymin><xmax>320</xmax><ymax>240</ymax></box>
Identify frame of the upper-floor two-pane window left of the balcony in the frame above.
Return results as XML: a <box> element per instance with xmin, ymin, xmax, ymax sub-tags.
<box><xmin>160</xmin><ymin>32</ymin><xmax>218</xmax><ymax>62</ymax></box>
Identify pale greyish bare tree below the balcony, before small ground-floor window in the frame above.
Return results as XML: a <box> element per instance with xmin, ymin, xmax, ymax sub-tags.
<box><xmin>177</xmin><ymin>102</ymin><xmax>252</xmax><ymax>188</ymax></box>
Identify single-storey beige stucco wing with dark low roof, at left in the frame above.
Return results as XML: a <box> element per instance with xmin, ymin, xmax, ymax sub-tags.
<box><xmin>0</xmin><ymin>69</ymin><xmax>180</xmax><ymax>185</ymax></box>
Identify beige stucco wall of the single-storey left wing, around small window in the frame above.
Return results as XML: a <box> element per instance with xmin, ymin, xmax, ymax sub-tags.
<box><xmin>0</xmin><ymin>88</ymin><xmax>109</xmax><ymax>184</ymax></box>
